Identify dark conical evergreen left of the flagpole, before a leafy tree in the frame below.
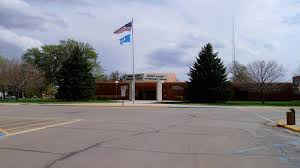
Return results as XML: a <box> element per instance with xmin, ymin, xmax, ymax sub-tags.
<box><xmin>56</xmin><ymin>45</ymin><xmax>96</xmax><ymax>100</ymax></box>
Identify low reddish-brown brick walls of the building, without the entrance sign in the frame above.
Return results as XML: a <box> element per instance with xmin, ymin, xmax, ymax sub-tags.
<box><xmin>96</xmin><ymin>81</ymin><xmax>300</xmax><ymax>101</ymax></box>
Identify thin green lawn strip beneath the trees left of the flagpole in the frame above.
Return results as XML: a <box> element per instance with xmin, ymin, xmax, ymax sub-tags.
<box><xmin>0</xmin><ymin>99</ymin><xmax>114</xmax><ymax>104</ymax></box>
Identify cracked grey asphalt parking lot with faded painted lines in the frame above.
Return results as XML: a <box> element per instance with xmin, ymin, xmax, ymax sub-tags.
<box><xmin>0</xmin><ymin>105</ymin><xmax>300</xmax><ymax>168</ymax></box>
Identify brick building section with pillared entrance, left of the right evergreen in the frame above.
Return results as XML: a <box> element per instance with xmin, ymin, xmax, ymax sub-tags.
<box><xmin>96</xmin><ymin>73</ymin><xmax>186</xmax><ymax>100</ymax></box>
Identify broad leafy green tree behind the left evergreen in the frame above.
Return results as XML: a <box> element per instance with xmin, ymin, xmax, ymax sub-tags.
<box><xmin>23</xmin><ymin>39</ymin><xmax>103</xmax><ymax>85</ymax></box>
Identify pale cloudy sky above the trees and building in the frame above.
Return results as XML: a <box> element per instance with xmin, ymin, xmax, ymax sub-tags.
<box><xmin>0</xmin><ymin>0</ymin><xmax>300</xmax><ymax>80</ymax></box>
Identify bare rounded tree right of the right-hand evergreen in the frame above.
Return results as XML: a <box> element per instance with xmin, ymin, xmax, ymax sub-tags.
<box><xmin>247</xmin><ymin>61</ymin><xmax>285</xmax><ymax>104</ymax></box>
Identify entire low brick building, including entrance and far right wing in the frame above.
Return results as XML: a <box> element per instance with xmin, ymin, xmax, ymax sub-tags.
<box><xmin>96</xmin><ymin>73</ymin><xmax>300</xmax><ymax>101</ymax></box>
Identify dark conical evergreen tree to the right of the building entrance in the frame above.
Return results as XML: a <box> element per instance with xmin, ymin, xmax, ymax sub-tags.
<box><xmin>187</xmin><ymin>43</ymin><xmax>229</xmax><ymax>102</ymax></box>
